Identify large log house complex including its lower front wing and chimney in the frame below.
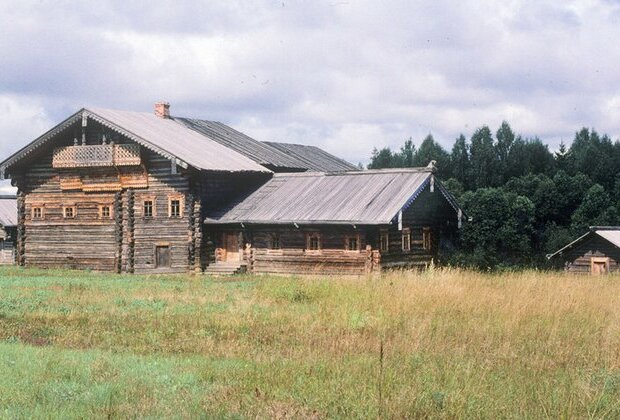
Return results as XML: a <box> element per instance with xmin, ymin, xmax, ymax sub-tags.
<box><xmin>0</xmin><ymin>103</ymin><xmax>462</xmax><ymax>274</ymax></box>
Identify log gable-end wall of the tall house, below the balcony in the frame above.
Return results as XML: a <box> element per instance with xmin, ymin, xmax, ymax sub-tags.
<box><xmin>14</xmin><ymin>124</ymin><xmax>191</xmax><ymax>273</ymax></box>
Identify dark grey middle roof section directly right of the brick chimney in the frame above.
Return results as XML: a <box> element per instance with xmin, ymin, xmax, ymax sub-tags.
<box><xmin>174</xmin><ymin>117</ymin><xmax>305</xmax><ymax>169</ymax></box>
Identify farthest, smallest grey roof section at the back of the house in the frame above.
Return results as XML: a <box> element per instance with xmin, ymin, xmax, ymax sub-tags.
<box><xmin>264</xmin><ymin>141</ymin><xmax>359</xmax><ymax>172</ymax></box>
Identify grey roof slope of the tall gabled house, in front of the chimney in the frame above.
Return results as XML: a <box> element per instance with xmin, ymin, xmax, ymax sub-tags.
<box><xmin>86</xmin><ymin>108</ymin><xmax>270</xmax><ymax>172</ymax></box>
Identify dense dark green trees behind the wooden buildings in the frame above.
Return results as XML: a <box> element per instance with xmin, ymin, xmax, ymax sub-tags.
<box><xmin>368</xmin><ymin>122</ymin><xmax>620</xmax><ymax>268</ymax></box>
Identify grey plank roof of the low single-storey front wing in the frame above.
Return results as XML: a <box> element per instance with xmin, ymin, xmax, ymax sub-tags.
<box><xmin>206</xmin><ymin>168</ymin><xmax>432</xmax><ymax>225</ymax></box>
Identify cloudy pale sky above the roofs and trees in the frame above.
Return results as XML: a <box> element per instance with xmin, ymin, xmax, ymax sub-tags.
<box><xmin>0</xmin><ymin>0</ymin><xmax>620</xmax><ymax>194</ymax></box>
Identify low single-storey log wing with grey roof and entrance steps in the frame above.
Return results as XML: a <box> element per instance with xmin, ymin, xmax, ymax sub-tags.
<box><xmin>205</xmin><ymin>165</ymin><xmax>462</xmax><ymax>275</ymax></box>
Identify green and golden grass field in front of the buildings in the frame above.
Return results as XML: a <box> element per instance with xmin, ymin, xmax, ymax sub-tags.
<box><xmin>0</xmin><ymin>268</ymin><xmax>620</xmax><ymax>418</ymax></box>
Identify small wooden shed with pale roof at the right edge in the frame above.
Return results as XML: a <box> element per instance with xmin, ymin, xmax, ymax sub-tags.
<box><xmin>547</xmin><ymin>226</ymin><xmax>620</xmax><ymax>275</ymax></box>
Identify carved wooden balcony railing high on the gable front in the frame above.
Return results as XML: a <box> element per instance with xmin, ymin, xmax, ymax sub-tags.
<box><xmin>52</xmin><ymin>144</ymin><xmax>141</xmax><ymax>168</ymax></box>
